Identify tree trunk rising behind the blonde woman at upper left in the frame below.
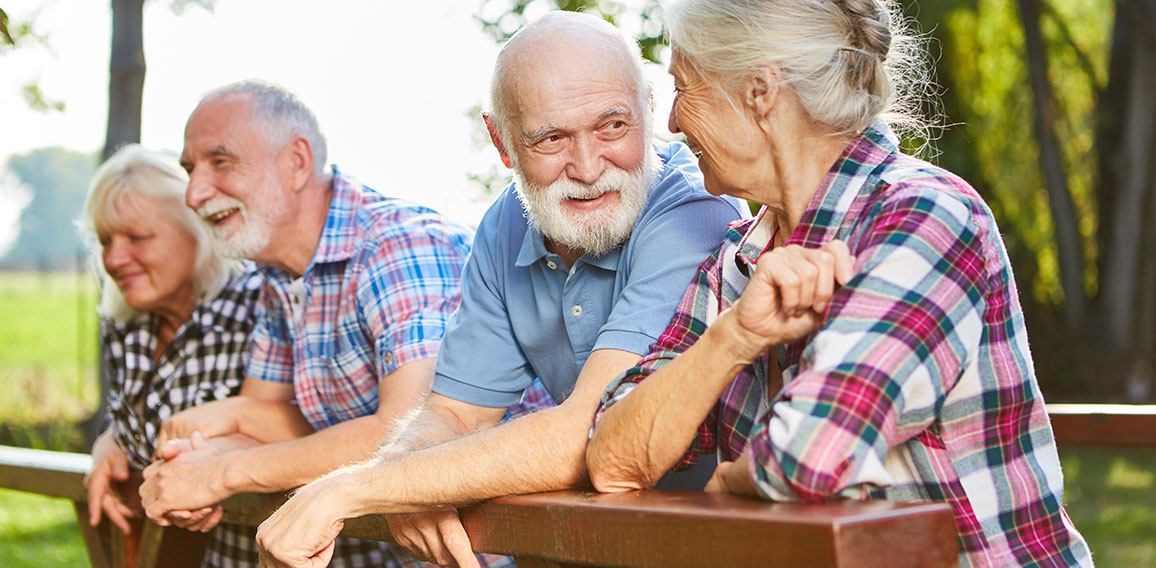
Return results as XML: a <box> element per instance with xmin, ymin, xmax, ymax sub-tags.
<box><xmin>102</xmin><ymin>0</ymin><xmax>145</xmax><ymax>160</ymax></box>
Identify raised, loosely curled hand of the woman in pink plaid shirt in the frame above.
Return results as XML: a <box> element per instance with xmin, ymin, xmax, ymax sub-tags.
<box><xmin>729</xmin><ymin>241</ymin><xmax>854</xmax><ymax>362</ymax></box>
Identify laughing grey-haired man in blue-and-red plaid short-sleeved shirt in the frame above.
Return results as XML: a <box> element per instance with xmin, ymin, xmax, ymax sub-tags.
<box><xmin>141</xmin><ymin>81</ymin><xmax>497</xmax><ymax>566</ymax></box>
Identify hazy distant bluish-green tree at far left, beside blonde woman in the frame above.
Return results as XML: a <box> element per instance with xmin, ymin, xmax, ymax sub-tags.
<box><xmin>3</xmin><ymin>148</ymin><xmax>96</xmax><ymax>270</ymax></box>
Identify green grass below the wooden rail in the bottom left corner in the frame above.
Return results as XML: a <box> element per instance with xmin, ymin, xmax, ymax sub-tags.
<box><xmin>0</xmin><ymin>489</ymin><xmax>88</xmax><ymax>568</ymax></box>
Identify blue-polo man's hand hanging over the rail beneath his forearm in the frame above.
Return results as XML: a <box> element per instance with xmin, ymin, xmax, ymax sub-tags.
<box><xmin>385</xmin><ymin>509</ymin><xmax>481</xmax><ymax>568</ymax></box>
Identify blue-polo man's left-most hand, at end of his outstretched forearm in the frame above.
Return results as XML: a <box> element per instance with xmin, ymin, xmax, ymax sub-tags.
<box><xmin>257</xmin><ymin>467</ymin><xmax>350</xmax><ymax>568</ymax></box>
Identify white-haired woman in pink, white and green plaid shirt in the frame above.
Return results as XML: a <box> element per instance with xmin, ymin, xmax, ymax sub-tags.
<box><xmin>587</xmin><ymin>0</ymin><xmax>1091</xmax><ymax>566</ymax></box>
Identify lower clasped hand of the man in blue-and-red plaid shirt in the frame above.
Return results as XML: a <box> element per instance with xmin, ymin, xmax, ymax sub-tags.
<box><xmin>140</xmin><ymin>431</ymin><xmax>230</xmax><ymax>531</ymax></box>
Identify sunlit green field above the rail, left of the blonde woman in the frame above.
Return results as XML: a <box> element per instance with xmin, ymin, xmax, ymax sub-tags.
<box><xmin>0</xmin><ymin>272</ymin><xmax>99</xmax><ymax>425</ymax></box>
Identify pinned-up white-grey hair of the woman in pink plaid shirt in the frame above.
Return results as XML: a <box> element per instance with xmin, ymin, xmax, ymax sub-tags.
<box><xmin>666</xmin><ymin>0</ymin><xmax>936</xmax><ymax>140</ymax></box>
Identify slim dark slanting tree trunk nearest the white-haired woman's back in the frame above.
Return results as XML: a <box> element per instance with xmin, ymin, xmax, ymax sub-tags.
<box><xmin>1018</xmin><ymin>0</ymin><xmax>1087</xmax><ymax>333</ymax></box>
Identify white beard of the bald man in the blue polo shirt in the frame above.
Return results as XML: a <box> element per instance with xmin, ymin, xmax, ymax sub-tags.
<box><xmin>513</xmin><ymin>148</ymin><xmax>662</xmax><ymax>257</ymax></box>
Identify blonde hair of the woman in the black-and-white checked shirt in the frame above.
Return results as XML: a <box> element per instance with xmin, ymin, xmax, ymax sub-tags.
<box><xmin>80</xmin><ymin>143</ymin><xmax>240</xmax><ymax>322</ymax></box>
